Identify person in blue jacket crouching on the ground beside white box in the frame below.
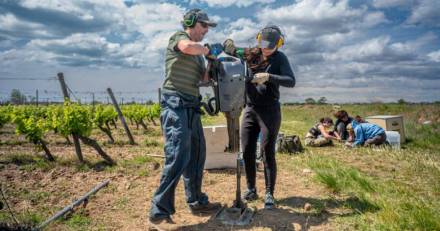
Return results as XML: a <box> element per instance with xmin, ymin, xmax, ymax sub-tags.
<box><xmin>345</xmin><ymin>120</ymin><xmax>387</xmax><ymax>147</ymax></box>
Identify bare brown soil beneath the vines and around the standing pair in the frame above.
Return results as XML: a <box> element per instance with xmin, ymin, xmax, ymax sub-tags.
<box><xmin>0</xmin><ymin>104</ymin><xmax>437</xmax><ymax>230</ymax></box>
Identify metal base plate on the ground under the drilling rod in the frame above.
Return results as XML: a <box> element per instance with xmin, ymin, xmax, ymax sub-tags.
<box><xmin>215</xmin><ymin>207</ymin><xmax>255</xmax><ymax>225</ymax></box>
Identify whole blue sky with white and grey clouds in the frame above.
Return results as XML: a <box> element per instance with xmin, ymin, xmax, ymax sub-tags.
<box><xmin>0</xmin><ymin>0</ymin><xmax>440</xmax><ymax>102</ymax></box>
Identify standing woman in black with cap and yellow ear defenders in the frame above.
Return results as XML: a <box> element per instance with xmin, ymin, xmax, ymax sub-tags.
<box><xmin>224</xmin><ymin>26</ymin><xmax>295</xmax><ymax>209</ymax></box>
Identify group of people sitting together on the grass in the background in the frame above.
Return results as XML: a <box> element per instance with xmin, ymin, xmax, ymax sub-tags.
<box><xmin>304</xmin><ymin>110</ymin><xmax>386</xmax><ymax>147</ymax></box>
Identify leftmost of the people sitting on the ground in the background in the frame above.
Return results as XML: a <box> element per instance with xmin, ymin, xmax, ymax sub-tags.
<box><xmin>304</xmin><ymin>117</ymin><xmax>341</xmax><ymax>147</ymax></box>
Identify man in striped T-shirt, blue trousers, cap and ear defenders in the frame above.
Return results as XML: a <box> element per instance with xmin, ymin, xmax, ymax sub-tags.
<box><xmin>149</xmin><ymin>9</ymin><xmax>223</xmax><ymax>230</ymax></box>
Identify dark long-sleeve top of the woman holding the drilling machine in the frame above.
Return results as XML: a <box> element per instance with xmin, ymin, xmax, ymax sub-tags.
<box><xmin>246</xmin><ymin>50</ymin><xmax>296</xmax><ymax>106</ymax></box>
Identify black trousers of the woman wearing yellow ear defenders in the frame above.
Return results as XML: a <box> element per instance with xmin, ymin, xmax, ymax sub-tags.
<box><xmin>241</xmin><ymin>104</ymin><xmax>281</xmax><ymax>194</ymax></box>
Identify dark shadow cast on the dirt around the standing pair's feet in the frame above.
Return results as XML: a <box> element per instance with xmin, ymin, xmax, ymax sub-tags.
<box><xmin>177</xmin><ymin>197</ymin><xmax>378</xmax><ymax>230</ymax></box>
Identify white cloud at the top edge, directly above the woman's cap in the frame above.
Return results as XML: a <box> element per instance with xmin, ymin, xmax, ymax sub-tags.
<box><xmin>257</xmin><ymin>0</ymin><xmax>387</xmax><ymax>42</ymax></box>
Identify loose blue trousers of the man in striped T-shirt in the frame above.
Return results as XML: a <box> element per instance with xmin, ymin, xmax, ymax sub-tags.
<box><xmin>150</xmin><ymin>92</ymin><xmax>208</xmax><ymax>218</ymax></box>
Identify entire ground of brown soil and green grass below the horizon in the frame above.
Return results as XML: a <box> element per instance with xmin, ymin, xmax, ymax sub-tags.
<box><xmin>0</xmin><ymin>104</ymin><xmax>440</xmax><ymax>230</ymax></box>
